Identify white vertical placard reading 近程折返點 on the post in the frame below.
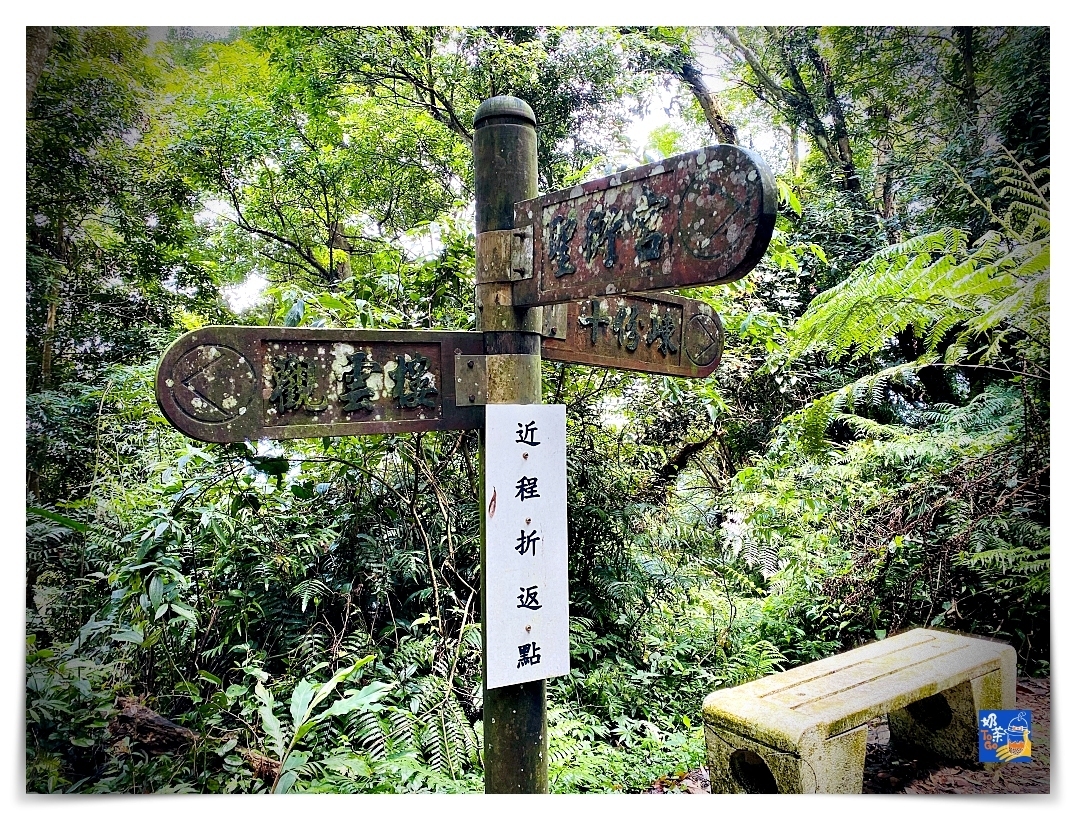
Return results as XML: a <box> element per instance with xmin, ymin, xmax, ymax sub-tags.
<box><xmin>483</xmin><ymin>405</ymin><xmax>568</xmax><ymax>689</ymax></box>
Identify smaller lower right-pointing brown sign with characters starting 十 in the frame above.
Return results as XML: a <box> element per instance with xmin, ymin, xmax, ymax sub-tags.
<box><xmin>541</xmin><ymin>294</ymin><xmax>724</xmax><ymax>377</ymax></box>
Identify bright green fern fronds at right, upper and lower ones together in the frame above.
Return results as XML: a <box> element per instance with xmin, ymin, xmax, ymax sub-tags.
<box><xmin>785</xmin><ymin>152</ymin><xmax>1050</xmax><ymax>454</ymax></box>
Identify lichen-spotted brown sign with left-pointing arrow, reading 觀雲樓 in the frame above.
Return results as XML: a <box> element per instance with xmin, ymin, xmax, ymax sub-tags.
<box><xmin>157</xmin><ymin>326</ymin><xmax>483</xmax><ymax>441</ymax></box>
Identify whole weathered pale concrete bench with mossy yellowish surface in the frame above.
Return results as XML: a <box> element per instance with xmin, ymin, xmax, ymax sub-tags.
<box><xmin>703</xmin><ymin>630</ymin><xmax>1016</xmax><ymax>794</ymax></box>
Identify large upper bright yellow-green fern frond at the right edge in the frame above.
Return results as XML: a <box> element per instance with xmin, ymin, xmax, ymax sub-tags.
<box><xmin>790</xmin><ymin>148</ymin><xmax>1050</xmax><ymax>372</ymax></box>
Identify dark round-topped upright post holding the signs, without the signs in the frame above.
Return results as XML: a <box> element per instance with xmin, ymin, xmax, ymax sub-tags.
<box><xmin>475</xmin><ymin>97</ymin><xmax>549</xmax><ymax>794</ymax></box>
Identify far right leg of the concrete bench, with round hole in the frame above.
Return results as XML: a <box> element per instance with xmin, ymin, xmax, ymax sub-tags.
<box><xmin>889</xmin><ymin>650</ymin><xmax>1016</xmax><ymax>763</ymax></box>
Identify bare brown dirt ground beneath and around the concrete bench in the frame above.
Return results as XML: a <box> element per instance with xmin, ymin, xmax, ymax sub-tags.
<box><xmin>649</xmin><ymin>678</ymin><xmax>1050</xmax><ymax>794</ymax></box>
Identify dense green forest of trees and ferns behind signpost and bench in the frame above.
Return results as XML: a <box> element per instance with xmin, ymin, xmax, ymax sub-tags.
<box><xmin>26</xmin><ymin>27</ymin><xmax>1050</xmax><ymax>792</ymax></box>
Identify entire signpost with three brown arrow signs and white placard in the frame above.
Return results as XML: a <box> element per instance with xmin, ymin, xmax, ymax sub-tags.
<box><xmin>156</xmin><ymin>97</ymin><xmax>776</xmax><ymax>793</ymax></box>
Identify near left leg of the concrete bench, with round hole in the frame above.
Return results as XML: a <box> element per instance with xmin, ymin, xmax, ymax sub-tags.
<box><xmin>706</xmin><ymin>725</ymin><xmax>867</xmax><ymax>794</ymax></box>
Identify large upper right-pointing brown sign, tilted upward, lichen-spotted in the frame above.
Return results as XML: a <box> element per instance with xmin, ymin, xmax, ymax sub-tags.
<box><xmin>512</xmin><ymin>145</ymin><xmax>777</xmax><ymax>306</ymax></box>
